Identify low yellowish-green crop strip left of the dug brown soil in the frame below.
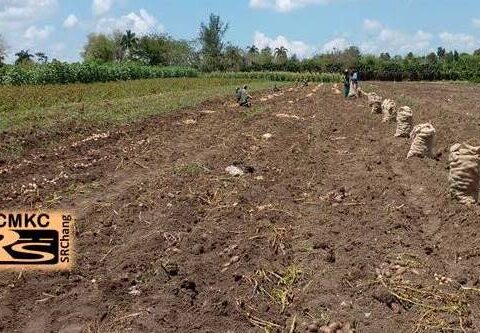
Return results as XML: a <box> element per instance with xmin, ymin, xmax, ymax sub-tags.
<box><xmin>0</xmin><ymin>78</ymin><xmax>288</xmax><ymax>134</ymax></box>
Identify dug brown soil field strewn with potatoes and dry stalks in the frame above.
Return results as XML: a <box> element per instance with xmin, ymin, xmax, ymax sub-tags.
<box><xmin>0</xmin><ymin>82</ymin><xmax>480</xmax><ymax>333</ymax></box>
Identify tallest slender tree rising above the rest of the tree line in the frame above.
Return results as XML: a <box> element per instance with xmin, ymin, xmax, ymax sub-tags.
<box><xmin>199</xmin><ymin>14</ymin><xmax>228</xmax><ymax>71</ymax></box>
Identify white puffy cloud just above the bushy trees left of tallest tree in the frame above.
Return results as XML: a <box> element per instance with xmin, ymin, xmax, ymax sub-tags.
<box><xmin>97</xmin><ymin>9</ymin><xmax>163</xmax><ymax>35</ymax></box>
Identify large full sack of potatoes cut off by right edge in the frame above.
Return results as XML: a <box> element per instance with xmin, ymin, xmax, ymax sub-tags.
<box><xmin>448</xmin><ymin>143</ymin><xmax>480</xmax><ymax>204</ymax></box>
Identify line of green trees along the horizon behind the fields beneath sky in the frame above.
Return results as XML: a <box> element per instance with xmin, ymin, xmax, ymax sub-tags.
<box><xmin>0</xmin><ymin>14</ymin><xmax>480</xmax><ymax>81</ymax></box>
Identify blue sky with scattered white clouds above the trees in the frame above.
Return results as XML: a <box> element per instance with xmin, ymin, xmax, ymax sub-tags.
<box><xmin>0</xmin><ymin>0</ymin><xmax>480</xmax><ymax>61</ymax></box>
